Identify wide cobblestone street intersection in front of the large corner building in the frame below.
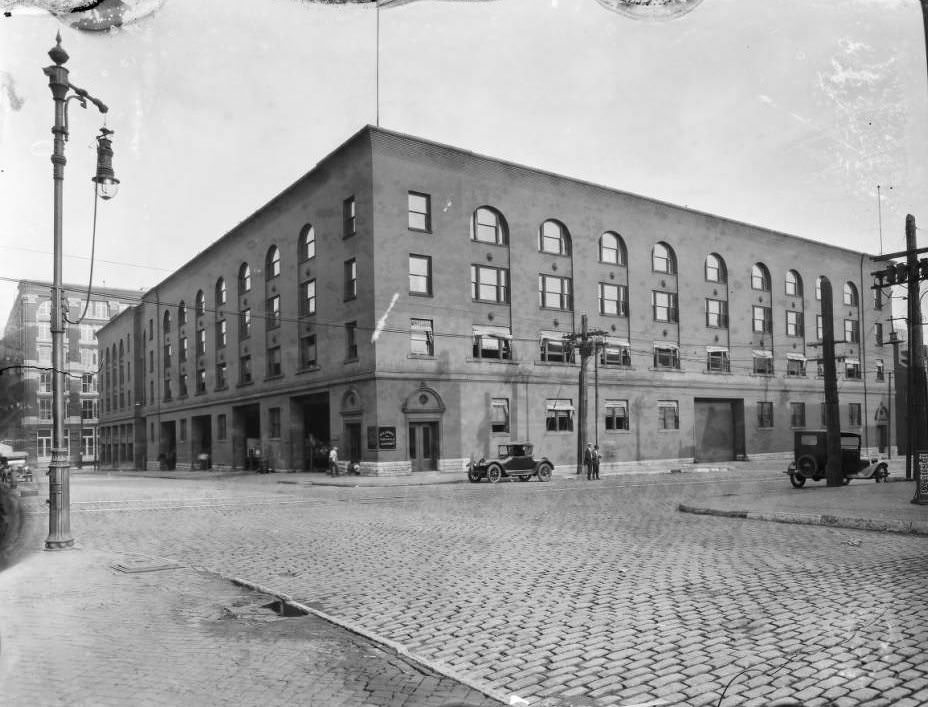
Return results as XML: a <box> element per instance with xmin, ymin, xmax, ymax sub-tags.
<box><xmin>1</xmin><ymin>474</ymin><xmax>928</xmax><ymax>707</ymax></box>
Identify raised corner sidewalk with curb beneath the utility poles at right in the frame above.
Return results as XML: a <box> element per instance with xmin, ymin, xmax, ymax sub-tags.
<box><xmin>678</xmin><ymin>459</ymin><xmax>928</xmax><ymax>536</ymax></box>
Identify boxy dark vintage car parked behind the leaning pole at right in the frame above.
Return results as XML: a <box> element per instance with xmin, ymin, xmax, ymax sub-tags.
<box><xmin>784</xmin><ymin>430</ymin><xmax>889</xmax><ymax>489</ymax></box>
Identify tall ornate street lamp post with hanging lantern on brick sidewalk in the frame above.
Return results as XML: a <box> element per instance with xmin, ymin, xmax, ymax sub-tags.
<box><xmin>42</xmin><ymin>32</ymin><xmax>119</xmax><ymax>550</ymax></box>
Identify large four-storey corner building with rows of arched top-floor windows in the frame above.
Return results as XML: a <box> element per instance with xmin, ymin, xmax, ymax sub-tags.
<box><xmin>99</xmin><ymin>126</ymin><xmax>889</xmax><ymax>474</ymax></box>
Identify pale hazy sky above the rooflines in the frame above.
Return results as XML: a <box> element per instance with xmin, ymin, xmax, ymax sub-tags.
<box><xmin>0</xmin><ymin>0</ymin><xmax>928</xmax><ymax>323</ymax></box>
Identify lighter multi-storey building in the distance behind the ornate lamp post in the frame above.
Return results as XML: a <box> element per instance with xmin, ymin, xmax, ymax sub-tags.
<box><xmin>0</xmin><ymin>281</ymin><xmax>139</xmax><ymax>466</ymax></box>
